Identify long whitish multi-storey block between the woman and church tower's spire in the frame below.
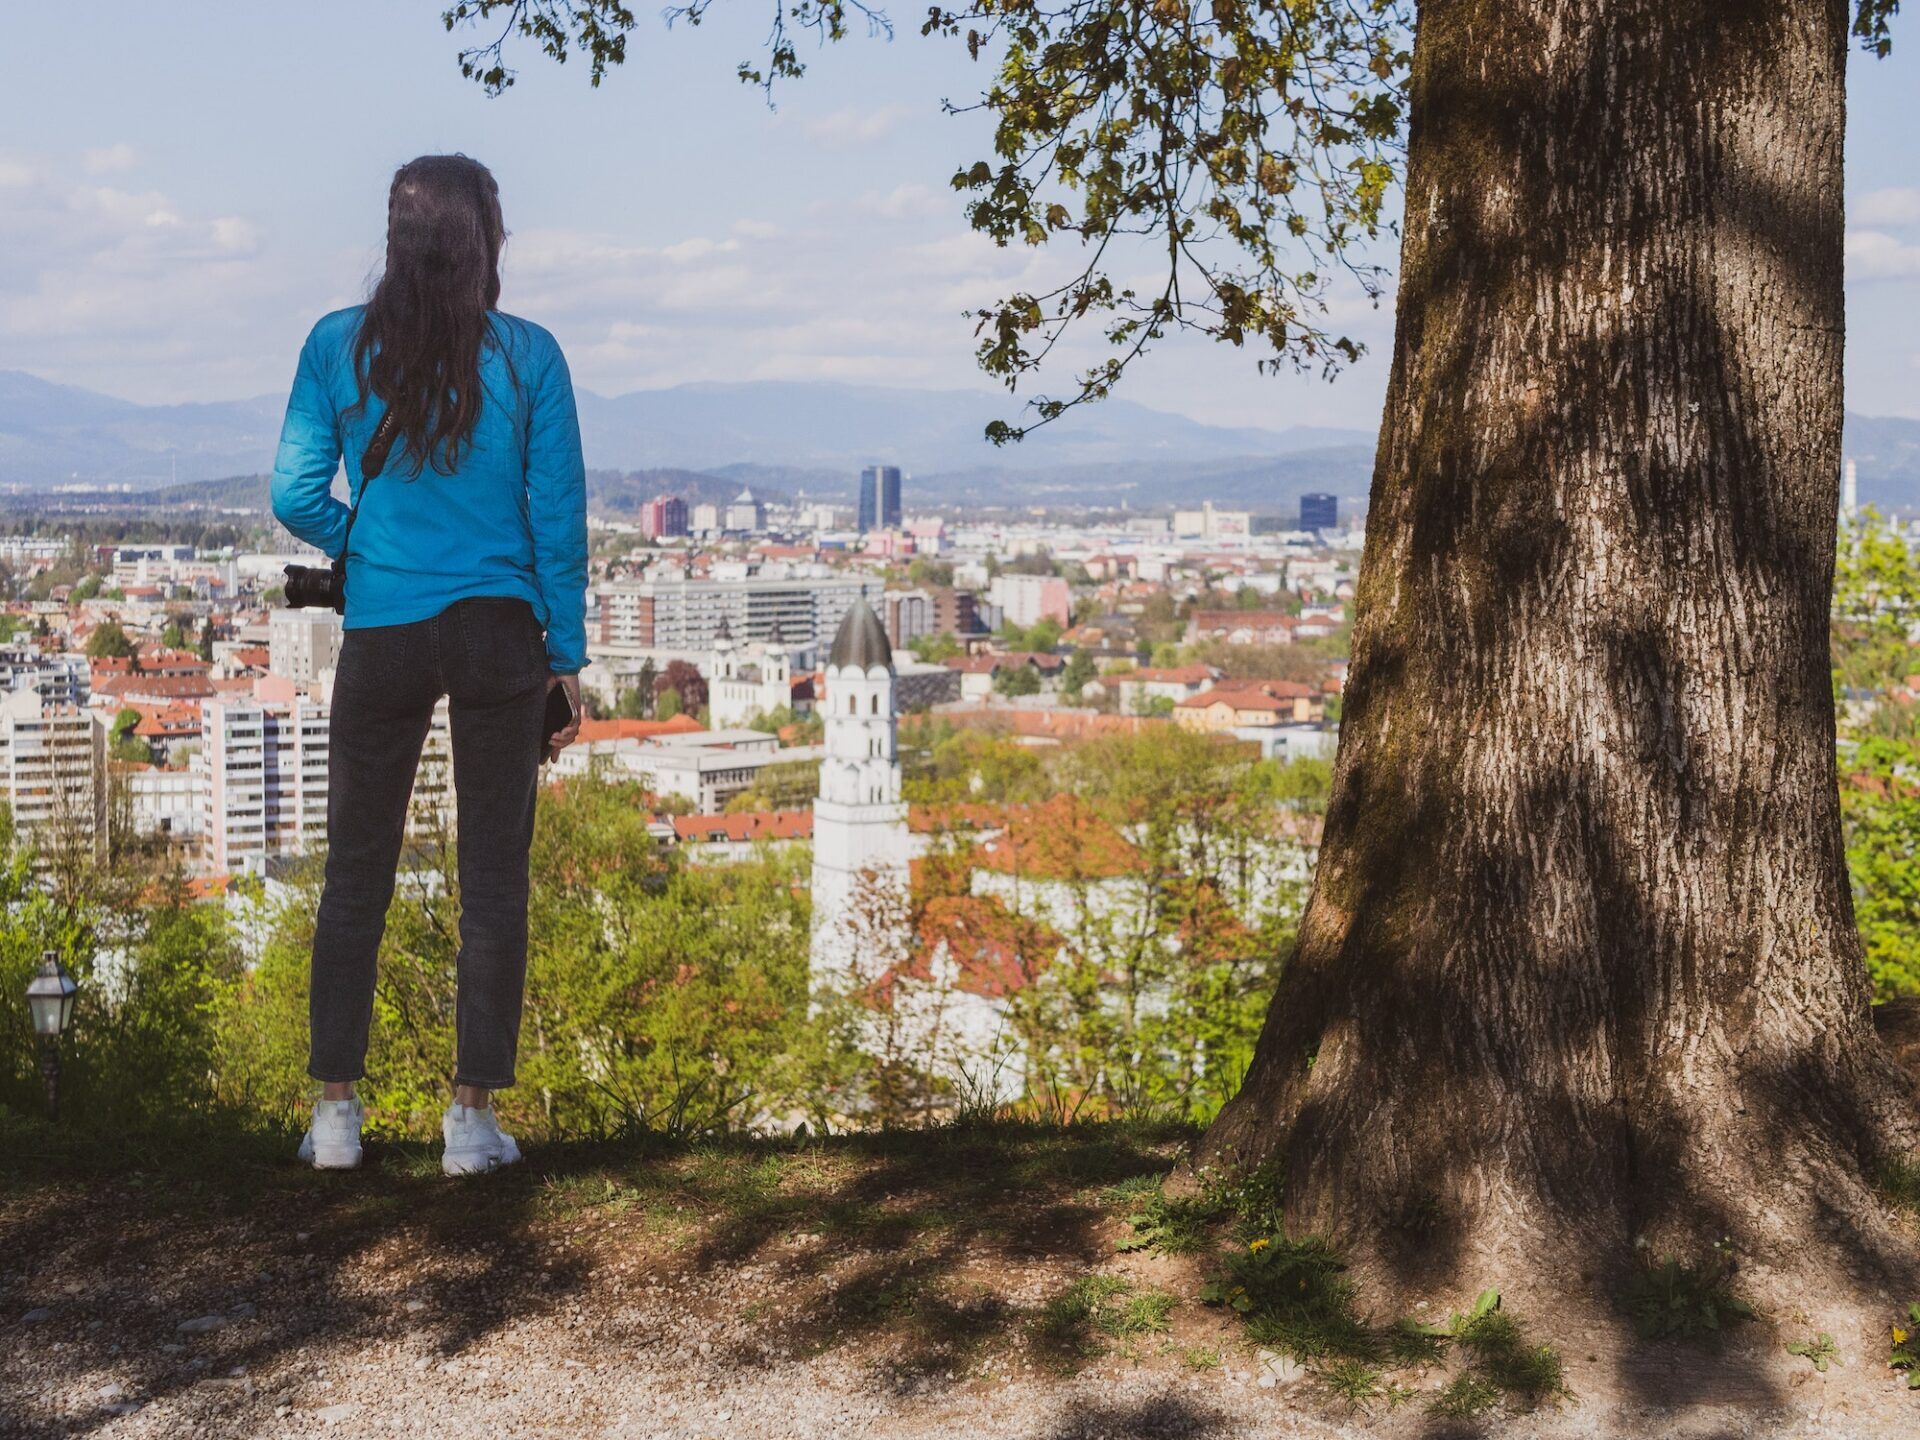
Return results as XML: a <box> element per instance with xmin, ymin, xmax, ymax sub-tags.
<box><xmin>599</xmin><ymin>564</ymin><xmax>883</xmax><ymax>653</ymax></box>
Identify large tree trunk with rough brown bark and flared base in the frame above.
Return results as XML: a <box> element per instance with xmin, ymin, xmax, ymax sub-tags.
<box><xmin>1198</xmin><ymin>0</ymin><xmax>1914</xmax><ymax>1283</ymax></box>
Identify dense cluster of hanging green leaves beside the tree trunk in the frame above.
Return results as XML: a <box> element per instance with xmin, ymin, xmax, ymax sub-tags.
<box><xmin>922</xmin><ymin>0</ymin><xmax>1411</xmax><ymax>444</ymax></box>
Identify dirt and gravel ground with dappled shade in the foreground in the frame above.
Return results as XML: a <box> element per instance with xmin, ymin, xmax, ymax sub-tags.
<box><xmin>0</xmin><ymin>1127</ymin><xmax>1920</xmax><ymax>1440</ymax></box>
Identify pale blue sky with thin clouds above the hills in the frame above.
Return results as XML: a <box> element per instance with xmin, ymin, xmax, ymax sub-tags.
<box><xmin>0</xmin><ymin>0</ymin><xmax>1920</xmax><ymax>430</ymax></box>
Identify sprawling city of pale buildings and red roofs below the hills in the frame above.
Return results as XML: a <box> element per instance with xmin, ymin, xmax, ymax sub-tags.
<box><xmin>0</xmin><ymin>480</ymin><xmax>1361</xmax><ymax>891</ymax></box>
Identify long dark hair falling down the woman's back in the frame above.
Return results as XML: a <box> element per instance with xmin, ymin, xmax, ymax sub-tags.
<box><xmin>353</xmin><ymin>156</ymin><xmax>507</xmax><ymax>474</ymax></box>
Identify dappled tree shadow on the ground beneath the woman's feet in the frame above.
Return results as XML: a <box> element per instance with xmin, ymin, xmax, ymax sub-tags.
<box><xmin>0</xmin><ymin>1116</ymin><xmax>1190</xmax><ymax>1436</ymax></box>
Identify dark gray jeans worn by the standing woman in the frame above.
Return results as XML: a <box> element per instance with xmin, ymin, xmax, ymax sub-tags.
<box><xmin>307</xmin><ymin>599</ymin><xmax>549</xmax><ymax>1091</ymax></box>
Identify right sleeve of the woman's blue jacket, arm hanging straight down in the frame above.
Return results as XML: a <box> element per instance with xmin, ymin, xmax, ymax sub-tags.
<box><xmin>526</xmin><ymin>346</ymin><xmax>588</xmax><ymax>676</ymax></box>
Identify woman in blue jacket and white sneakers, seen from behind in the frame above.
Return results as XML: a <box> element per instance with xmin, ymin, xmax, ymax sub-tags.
<box><xmin>273</xmin><ymin>156</ymin><xmax>588</xmax><ymax>1175</ymax></box>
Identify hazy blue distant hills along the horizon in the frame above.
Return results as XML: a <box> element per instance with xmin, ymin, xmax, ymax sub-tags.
<box><xmin>0</xmin><ymin>371</ymin><xmax>1920</xmax><ymax>513</ymax></box>
